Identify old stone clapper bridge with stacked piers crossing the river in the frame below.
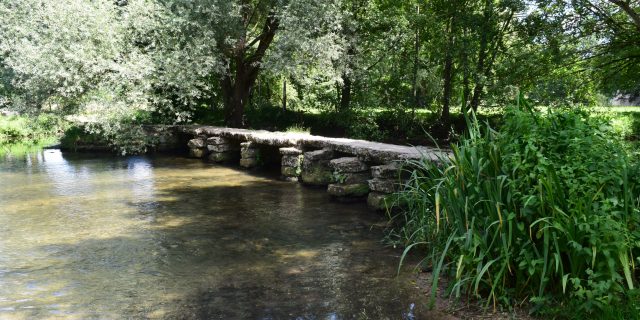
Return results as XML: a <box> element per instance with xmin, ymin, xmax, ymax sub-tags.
<box><xmin>161</xmin><ymin>125</ymin><xmax>443</xmax><ymax>210</ymax></box>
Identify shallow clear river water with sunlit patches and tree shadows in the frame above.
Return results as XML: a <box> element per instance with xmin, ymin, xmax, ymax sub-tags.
<box><xmin>0</xmin><ymin>150</ymin><xmax>426</xmax><ymax>319</ymax></box>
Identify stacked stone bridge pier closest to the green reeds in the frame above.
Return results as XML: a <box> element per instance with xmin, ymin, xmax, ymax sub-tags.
<box><xmin>367</xmin><ymin>162</ymin><xmax>405</xmax><ymax>210</ymax></box>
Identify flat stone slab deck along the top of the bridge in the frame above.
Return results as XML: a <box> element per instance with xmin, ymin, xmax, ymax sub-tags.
<box><xmin>177</xmin><ymin>125</ymin><xmax>449</xmax><ymax>164</ymax></box>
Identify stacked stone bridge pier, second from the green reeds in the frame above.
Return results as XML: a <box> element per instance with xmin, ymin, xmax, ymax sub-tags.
<box><xmin>327</xmin><ymin>157</ymin><xmax>371</xmax><ymax>199</ymax></box>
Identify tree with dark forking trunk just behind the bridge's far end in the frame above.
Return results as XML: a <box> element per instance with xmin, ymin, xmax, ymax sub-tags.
<box><xmin>155</xmin><ymin>0</ymin><xmax>340</xmax><ymax>127</ymax></box>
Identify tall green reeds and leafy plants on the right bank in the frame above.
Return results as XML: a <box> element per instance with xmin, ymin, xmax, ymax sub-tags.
<box><xmin>390</xmin><ymin>104</ymin><xmax>640</xmax><ymax>316</ymax></box>
